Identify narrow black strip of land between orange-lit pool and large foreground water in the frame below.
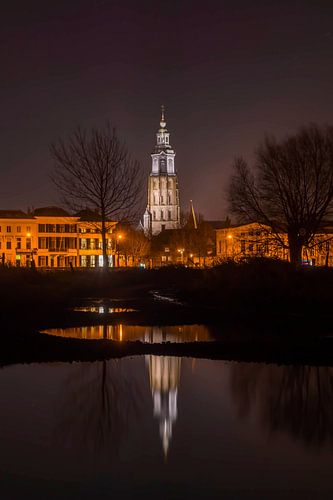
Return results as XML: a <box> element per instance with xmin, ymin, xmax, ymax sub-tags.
<box><xmin>0</xmin><ymin>331</ymin><xmax>333</xmax><ymax>366</ymax></box>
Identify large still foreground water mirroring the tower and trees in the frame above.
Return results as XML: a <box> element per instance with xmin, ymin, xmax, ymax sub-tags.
<box><xmin>0</xmin><ymin>356</ymin><xmax>333</xmax><ymax>499</ymax></box>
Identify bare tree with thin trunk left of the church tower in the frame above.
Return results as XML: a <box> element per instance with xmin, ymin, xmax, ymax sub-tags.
<box><xmin>50</xmin><ymin>124</ymin><xmax>142</xmax><ymax>268</ymax></box>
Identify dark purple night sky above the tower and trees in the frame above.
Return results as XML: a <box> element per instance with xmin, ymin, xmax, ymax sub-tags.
<box><xmin>0</xmin><ymin>0</ymin><xmax>333</xmax><ymax>218</ymax></box>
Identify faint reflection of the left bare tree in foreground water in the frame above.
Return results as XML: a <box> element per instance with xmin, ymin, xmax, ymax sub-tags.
<box><xmin>55</xmin><ymin>360</ymin><xmax>141</xmax><ymax>455</ymax></box>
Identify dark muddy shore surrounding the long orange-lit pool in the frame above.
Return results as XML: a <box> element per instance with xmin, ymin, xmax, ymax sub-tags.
<box><xmin>0</xmin><ymin>299</ymin><xmax>333</xmax><ymax>366</ymax></box>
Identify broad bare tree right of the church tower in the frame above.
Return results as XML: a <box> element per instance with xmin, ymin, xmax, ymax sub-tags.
<box><xmin>229</xmin><ymin>125</ymin><xmax>333</xmax><ymax>263</ymax></box>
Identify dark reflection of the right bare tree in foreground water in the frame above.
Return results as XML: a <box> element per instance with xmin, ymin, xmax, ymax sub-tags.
<box><xmin>231</xmin><ymin>363</ymin><xmax>333</xmax><ymax>446</ymax></box>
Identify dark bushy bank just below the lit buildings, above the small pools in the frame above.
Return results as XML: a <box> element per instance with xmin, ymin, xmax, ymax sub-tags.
<box><xmin>0</xmin><ymin>259</ymin><xmax>333</xmax><ymax>322</ymax></box>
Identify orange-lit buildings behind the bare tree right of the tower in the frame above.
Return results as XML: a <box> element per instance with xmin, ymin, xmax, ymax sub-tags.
<box><xmin>216</xmin><ymin>223</ymin><xmax>333</xmax><ymax>266</ymax></box>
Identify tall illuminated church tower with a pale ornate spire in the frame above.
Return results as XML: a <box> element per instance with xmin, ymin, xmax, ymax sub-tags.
<box><xmin>143</xmin><ymin>106</ymin><xmax>180</xmax><ymax>236</ymax></box>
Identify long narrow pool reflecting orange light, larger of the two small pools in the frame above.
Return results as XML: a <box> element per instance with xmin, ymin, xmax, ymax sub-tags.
<box><xmin>44</xmin><ymin>324</ymin><xmax>212</xmax><ymax>344</ymax></box>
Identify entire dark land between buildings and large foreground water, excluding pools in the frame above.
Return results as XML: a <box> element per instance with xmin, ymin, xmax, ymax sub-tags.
<box><xmin>0</xmin><ymin>259</ymin><xmax>333</xmax><ymax>364</ymax></box>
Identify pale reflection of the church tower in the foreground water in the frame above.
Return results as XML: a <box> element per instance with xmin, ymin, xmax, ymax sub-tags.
<box><xmin>146</xmin><ymin>356</ymin><xmax>181</xmax><ymax>456</ymax></box>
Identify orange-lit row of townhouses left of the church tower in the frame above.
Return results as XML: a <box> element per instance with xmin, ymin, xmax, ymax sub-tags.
<box><xmin>0</xmin><ymin>207</ymin><xmax>116</xmax><ymax>268</ymax></box>
